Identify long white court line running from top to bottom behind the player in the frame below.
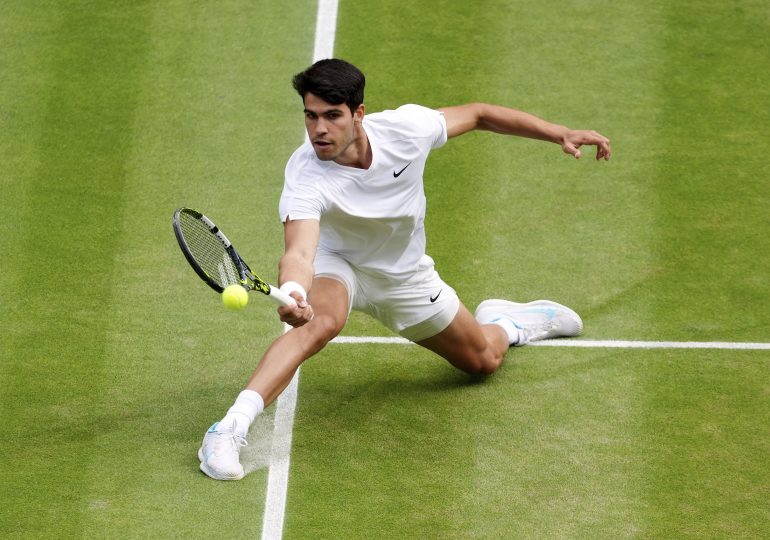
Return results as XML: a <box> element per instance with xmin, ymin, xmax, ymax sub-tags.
<box><xmin>262</xmin><ymin>0</ymin><xmax>337</xmax><ymax>540</ymax></box>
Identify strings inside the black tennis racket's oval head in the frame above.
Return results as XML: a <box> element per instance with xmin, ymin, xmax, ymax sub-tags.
<box><xmin>179</xmin><ymin>213</ymin><xmax>240</xmax><ymax>288</ymax></box>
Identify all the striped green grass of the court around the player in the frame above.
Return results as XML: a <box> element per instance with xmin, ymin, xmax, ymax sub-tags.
<box><xmin>0</xmin><ymin>0</ymin><xmax>770</xmax><ymax>538</ymax></box>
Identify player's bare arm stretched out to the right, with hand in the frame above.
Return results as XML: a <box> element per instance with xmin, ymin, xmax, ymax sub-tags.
<box><xmin>439</xmin><ymin>103</ymin><xmax>611</xmax><ymax>160</ymax></box>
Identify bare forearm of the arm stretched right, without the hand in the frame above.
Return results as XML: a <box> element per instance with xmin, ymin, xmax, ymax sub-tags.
<box><xmin>477</xmin><ymin>104</ymin><xmax>569</xmax><ymax>144</ymax></box>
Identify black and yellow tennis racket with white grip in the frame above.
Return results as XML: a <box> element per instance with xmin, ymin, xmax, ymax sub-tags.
<box><xmin>173</xmin><ymin>208</ymin><xmax>296</xmax><ymax>306</ymax></box>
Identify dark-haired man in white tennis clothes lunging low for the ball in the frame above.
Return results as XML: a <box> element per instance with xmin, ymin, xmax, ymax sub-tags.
<box><xmin>198</xmin><ymin>59</ymin><xmax>610</xmax><ymax>480</ymax></box>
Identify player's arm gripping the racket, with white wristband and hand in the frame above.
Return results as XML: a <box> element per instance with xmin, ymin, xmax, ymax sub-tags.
<box><xmin>278</xmin><ymin>219</ymin><xmax>320</xmax><ymax>327</ymax></box>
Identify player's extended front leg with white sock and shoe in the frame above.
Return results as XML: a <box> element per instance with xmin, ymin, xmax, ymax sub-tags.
<box><xmin>198</xmin><ymin>278</ymin><xmax>348</xmax><ymax>480</ymax></box>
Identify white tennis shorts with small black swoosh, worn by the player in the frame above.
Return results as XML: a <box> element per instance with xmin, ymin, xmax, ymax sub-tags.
<box><xmin>315</xmin><ymin>250</ymin><xmax>460</xmax><ymax>341</ymax></box>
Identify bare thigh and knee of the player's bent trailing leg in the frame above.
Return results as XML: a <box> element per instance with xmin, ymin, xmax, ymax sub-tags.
<box><xmin>417</xmin><ymin>304</ymin><xmax>509</xmax><ymax>375</ymax></box>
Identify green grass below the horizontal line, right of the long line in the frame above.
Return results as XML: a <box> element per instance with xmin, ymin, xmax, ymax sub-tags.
<box><xmin>287</xmin><ymin>345</ymin><xmax>770</xmax><ymax>538</ymax></box>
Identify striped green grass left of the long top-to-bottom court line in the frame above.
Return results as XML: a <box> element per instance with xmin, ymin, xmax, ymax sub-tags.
<box><xmin>0</xmin><ymin>2</ymin><xmax>312</xmax><ymax>537</ymax></box>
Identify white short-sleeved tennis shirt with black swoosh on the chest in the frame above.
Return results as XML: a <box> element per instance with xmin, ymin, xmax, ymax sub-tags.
<box><xmin>279</xmin><ymin>105</ymin><xmax>447</xmax><ymax>280</ymax></box>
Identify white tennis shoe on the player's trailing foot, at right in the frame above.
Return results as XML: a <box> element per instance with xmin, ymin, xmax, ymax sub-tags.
<box><xmin>476</xmin><ymin>300</ymin><xmax>583</xmax><ymax>345</ymax></box>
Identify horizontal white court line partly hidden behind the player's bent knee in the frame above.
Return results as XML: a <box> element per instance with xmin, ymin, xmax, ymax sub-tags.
<box><xmin>332</xmin><ymin>336</ymin><xmax>770</xmax><ymax>350</ymax></box>
